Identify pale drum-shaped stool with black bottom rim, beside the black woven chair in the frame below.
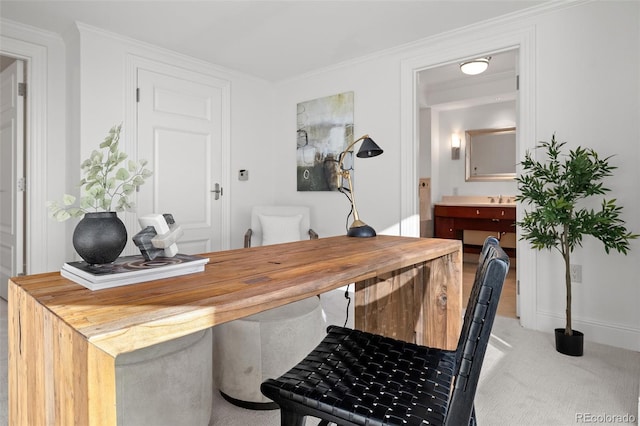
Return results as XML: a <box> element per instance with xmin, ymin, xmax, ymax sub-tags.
<box><xmin>213</xmin><ymin>296</ymin><xmax>326</xmax><ymax>410</ymax></box>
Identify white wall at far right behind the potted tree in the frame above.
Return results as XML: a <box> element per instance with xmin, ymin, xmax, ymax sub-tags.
<box><xmin>536</xmin><ymin>2</ymin><xmax>640</xmax><ymax>350</ymax></box>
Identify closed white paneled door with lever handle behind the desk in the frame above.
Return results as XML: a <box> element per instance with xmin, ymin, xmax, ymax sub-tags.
<box><xmin>137</xmin><ymin>68</ymin><xmax>228</xmax><ymax>254</ymax></box>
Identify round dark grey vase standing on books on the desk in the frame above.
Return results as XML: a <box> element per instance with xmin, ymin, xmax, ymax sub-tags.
<box><xmin>73</xmin><ymin>212</ymin><xmax>127</xmax><ymax>264</ymax></box>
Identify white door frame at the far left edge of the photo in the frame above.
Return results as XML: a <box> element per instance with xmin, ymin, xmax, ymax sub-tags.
<box><xmin>0</xmin><ymin>35</ymin><xmax>48</xmax><ymax>274</ymax></box>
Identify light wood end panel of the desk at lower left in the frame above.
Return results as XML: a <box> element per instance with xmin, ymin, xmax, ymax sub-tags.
<box><xmin>9</xmin><ymin>283</ymin><xmax>116</xmax><ymax>425</ymax></box>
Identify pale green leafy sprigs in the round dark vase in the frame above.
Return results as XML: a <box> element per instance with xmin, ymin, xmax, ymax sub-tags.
<box><xmin>48</xmin><ymin>124</ymin><xmax>152</xmax><ymax>221</ymax></box>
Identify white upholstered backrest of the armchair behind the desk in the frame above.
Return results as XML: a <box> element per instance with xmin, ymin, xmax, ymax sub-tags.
<box><xmin>251</xmin><ymin>206</ymin><xmax>311</xmax><ymax>247</ymax></box>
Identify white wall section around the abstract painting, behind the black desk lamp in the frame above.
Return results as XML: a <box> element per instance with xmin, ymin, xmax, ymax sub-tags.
<box><xmin>273</xmin><ymin>56</ymin><xmax>402</xmax><ymax>236</ymax></box>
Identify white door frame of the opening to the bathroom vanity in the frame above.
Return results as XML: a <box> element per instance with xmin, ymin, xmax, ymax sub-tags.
<box><xmin>400</xmin><ymin>22</ymin><xmax>537</xmax><ymax>329</ymax></box>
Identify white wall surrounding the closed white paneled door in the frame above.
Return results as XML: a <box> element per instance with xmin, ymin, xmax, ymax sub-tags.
<box><xmin>67</xmin><ymin>25</ymin><xmax>276</xmax><ymax>257</ymax></box>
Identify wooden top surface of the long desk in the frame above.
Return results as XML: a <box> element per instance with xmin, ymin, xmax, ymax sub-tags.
<box><xmin>9</xmin><ymin>236</ymin><xmax>461</xmax><ymax>357</ymax></box>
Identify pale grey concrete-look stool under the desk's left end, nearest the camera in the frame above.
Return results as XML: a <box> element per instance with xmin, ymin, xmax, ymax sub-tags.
<box><xmin>116</xmin><ymin>328</ymin><xmax>213</xmax><ymax>426</ymax></box>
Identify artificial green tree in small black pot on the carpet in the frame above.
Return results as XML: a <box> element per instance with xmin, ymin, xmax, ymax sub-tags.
<box><xmin>516</xmin><ymin>134</ymin><xmax>638</xmax><ymax>356</ymax></box>
